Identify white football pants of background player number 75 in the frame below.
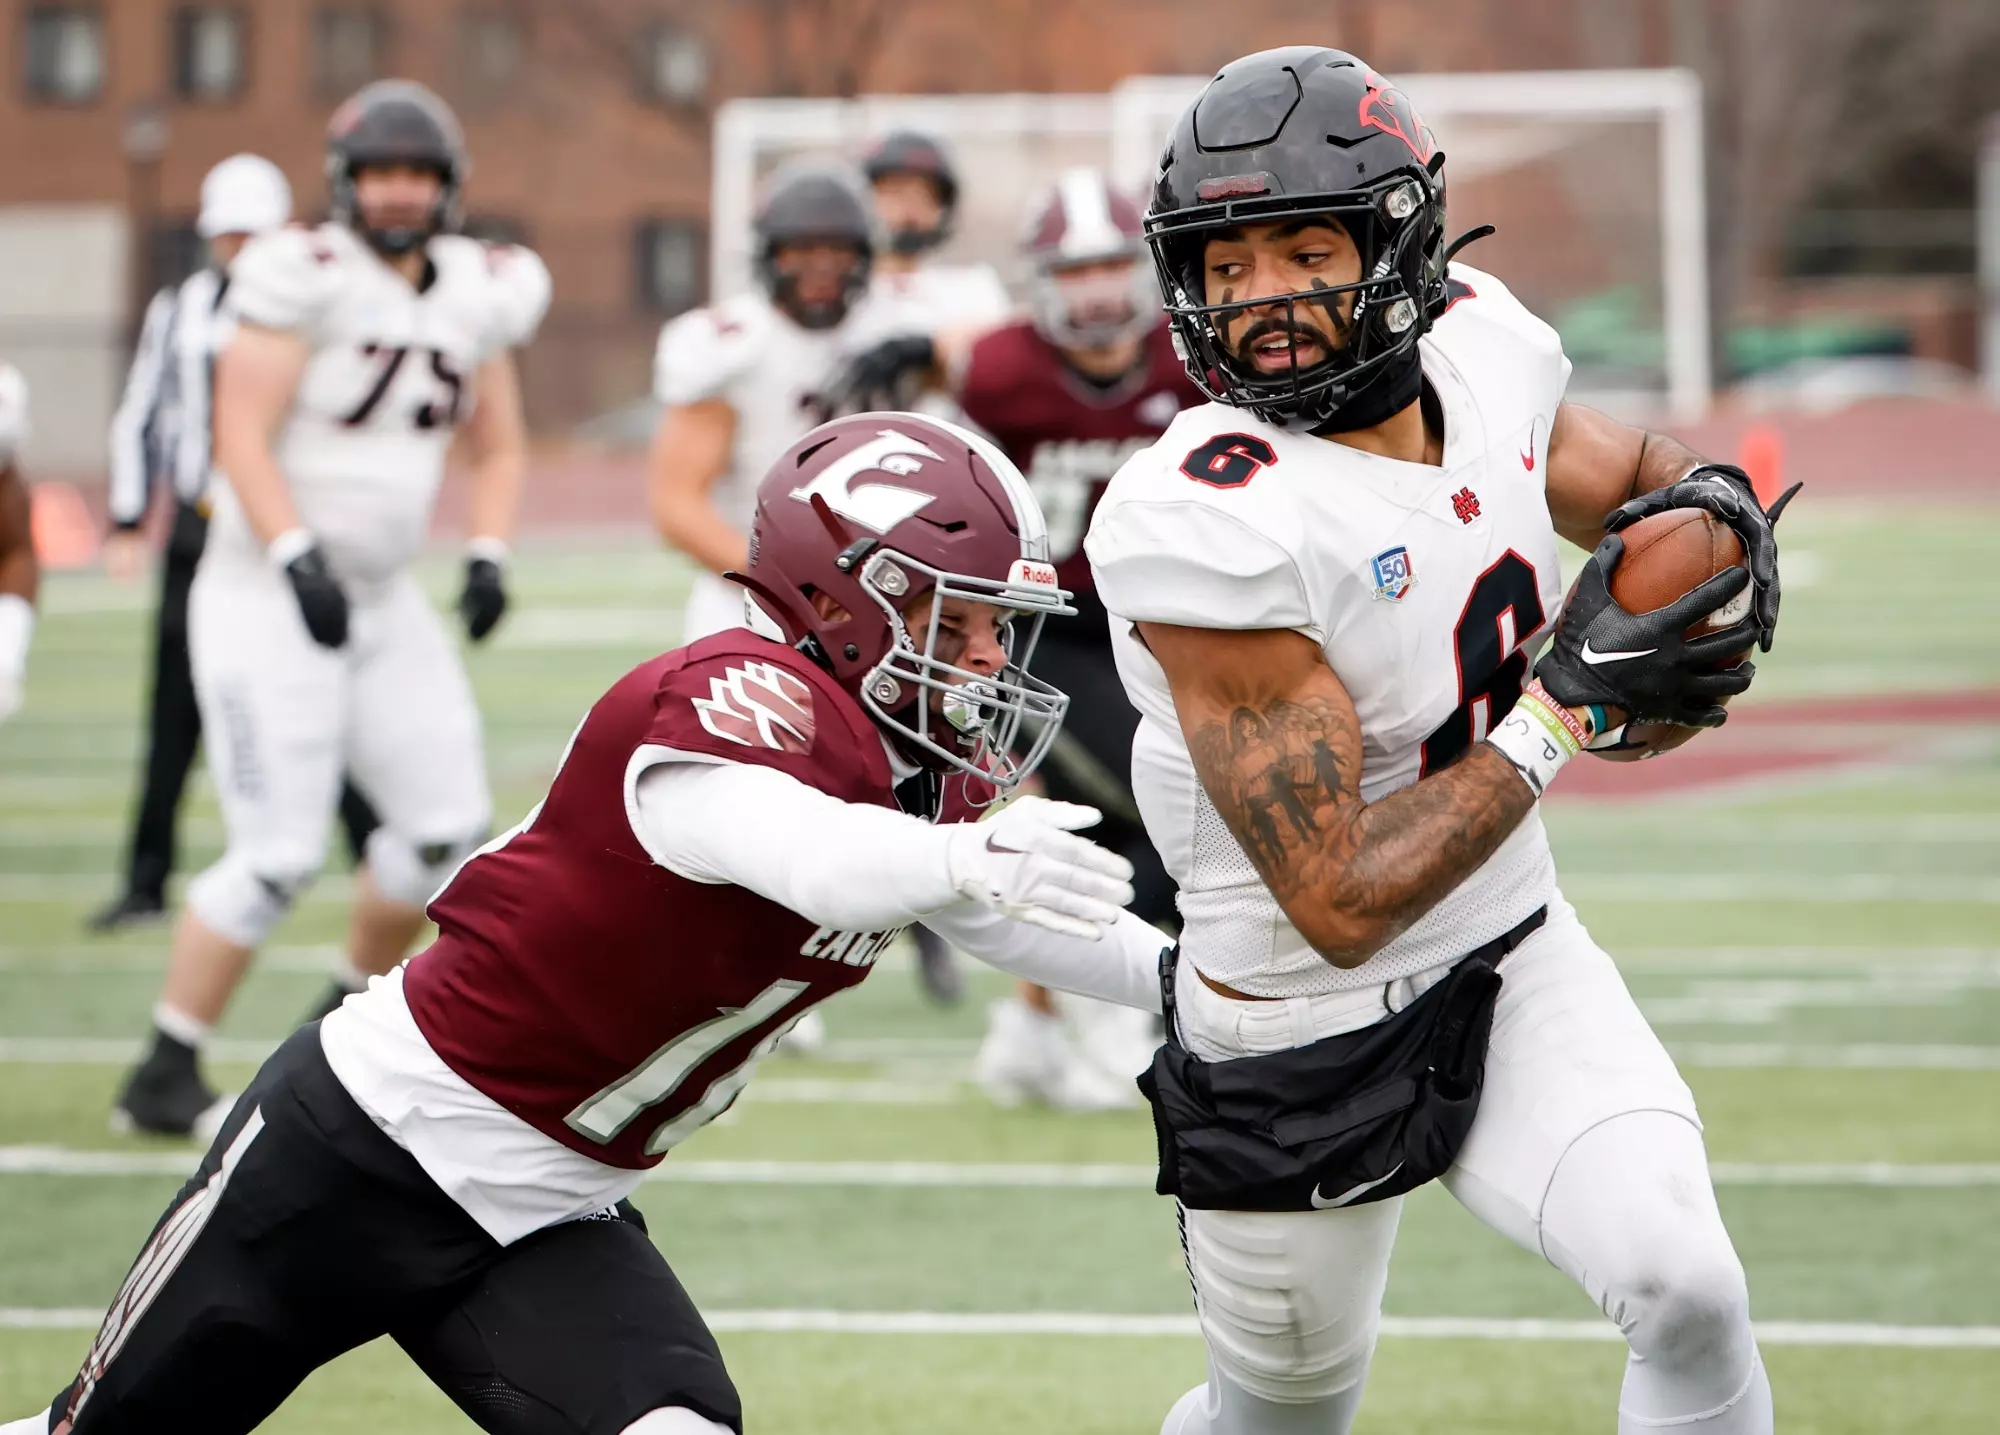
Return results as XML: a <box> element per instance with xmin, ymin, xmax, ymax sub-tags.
<box><xmin>188</xmin><ymin>548</ymin><xmax>492</xmax><ymax>947</ymax></box>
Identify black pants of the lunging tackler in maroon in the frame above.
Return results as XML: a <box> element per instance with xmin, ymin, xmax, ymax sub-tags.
<box><xmin>52</xmin><ymin>1023</ymin><xmax>742</xmax><ymax>1435</ymax></box>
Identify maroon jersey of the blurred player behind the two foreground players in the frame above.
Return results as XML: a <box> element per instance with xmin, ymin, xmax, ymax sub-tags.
<box><xmin>958</xmin><ymin>320</ymin><xmax>1206</xmax><ymax>610</ymax></box>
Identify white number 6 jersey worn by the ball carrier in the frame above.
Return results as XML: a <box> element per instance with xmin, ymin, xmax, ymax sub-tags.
<box><xmin>1084</xmin><ymin>266</ymin><xmax>1570</xmax><ymax>997</ymax></box>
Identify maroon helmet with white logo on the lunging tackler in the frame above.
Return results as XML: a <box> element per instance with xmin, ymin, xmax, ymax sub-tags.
<box><xmin>732</xmin><ymin>414</ymin><xmax>1076</xmax><ymax>789</ymax></box>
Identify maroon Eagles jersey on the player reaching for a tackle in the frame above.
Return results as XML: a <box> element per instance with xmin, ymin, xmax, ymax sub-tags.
<box><xmin>404</xmin><ymin>628</ymin><xmax>936</xmax><ymax>1167</ymax></box>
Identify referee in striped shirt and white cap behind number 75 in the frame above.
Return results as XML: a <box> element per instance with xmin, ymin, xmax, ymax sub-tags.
<box><xmin>88</xmin><ymin>154</ymin><xmax>378</xmax><ymax>931</ymax></box>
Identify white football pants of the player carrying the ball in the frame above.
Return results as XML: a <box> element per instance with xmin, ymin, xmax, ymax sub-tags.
<box><xmin>1162</xmin><ymin>897</ymin><xmax>1772</xmax><ymax>1435</ymax></box>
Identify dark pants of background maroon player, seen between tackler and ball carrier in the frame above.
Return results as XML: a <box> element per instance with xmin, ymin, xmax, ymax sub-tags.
<box><xmin>1030</xmin><ymin>620</ymin><xmax>1180</xmax><ymax>929</ymax></box>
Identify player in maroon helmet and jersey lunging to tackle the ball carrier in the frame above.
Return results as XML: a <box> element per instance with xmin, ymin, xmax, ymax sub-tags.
<box><xmin>15</xmin><ymin>414</ymin><xmax>1162</xmax><ymax>1435</ymax></box>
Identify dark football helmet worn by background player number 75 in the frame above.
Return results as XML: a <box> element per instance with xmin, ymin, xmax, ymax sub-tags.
<box><xmin>326</xmin><ymin>80</ymin><xmax>472</xmax><ymax>256</ymax></box>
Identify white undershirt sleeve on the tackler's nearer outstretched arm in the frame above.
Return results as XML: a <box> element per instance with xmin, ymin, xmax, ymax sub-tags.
<box><xmin>626</xmin><ymin>763</ymin><xmax>960</xmax><ymax>931</ymax></box>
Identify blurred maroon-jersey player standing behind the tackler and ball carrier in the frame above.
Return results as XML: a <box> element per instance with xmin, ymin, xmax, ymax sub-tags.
<box><xmin>958</xmin><ymin>168</ymin><xmax>1202</xmax><ymax>1107</ymax></box>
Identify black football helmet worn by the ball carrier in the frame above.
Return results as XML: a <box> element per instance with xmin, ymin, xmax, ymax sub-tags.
<box><xmin>1146</xmin><ymin>46</ymin><xmax>1488</xmax><ymax>434</ymax></box>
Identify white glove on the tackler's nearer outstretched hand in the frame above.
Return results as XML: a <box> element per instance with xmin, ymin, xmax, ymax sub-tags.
<box><xmin>946</xmin><ymin>797</ymin><xmax>1132</xmax><ymax>941</ymax></box>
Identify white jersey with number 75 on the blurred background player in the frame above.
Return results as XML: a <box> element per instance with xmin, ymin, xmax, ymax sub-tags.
<box><xmin>212</xmin><ymin>224</ymin><xmax>550</xmax><ymax>596</ymax></box>
